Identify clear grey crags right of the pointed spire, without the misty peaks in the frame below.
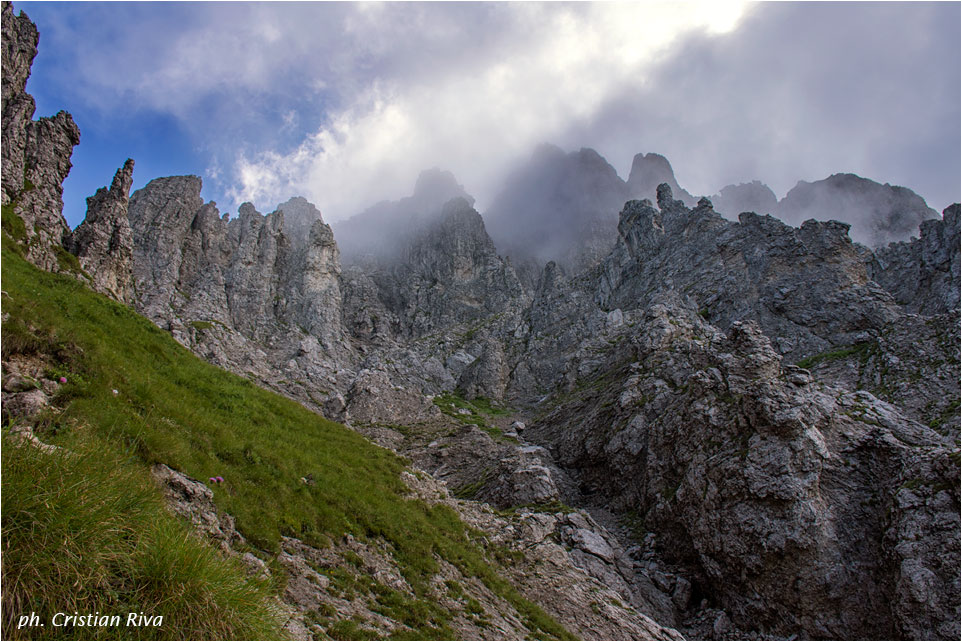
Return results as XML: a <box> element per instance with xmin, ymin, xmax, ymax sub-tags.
<box><xmin>112</xmin><ymin>172</ymin><xmax>959</xmax><ymax>637</ymax></box>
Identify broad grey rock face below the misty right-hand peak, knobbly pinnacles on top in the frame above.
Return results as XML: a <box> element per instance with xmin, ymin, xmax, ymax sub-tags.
<box><xmin>596</xmin><ymin>185</ymin><xmax>898</xmax><ymax>359</ymax></box>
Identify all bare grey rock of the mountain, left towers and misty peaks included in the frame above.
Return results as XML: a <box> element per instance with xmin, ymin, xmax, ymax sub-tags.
<box><xmin>2</xmin><ymin>4</ymin><xmax>962</xmax><ymax>639</ymax></box>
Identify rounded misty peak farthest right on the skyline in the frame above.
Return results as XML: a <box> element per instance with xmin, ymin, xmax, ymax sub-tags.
<box><xmin>777</xmin><ymin>174</ymin><xmax>938</xmax><ymax>247</ymax></box>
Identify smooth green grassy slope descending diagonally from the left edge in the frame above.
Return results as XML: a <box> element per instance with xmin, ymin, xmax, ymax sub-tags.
<box><xmin>2</xmin><ymin>232</ymin><xmax>569</xmax><ymax>637</ymax></box>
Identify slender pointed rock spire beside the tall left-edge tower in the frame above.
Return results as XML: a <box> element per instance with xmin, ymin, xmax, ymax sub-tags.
<box><xmin>66</xmin><ymin>159</ymin><xmax>134</xmax><ymax>303</ymax></box>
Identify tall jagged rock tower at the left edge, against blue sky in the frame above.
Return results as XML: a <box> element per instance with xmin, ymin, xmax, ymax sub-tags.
<box><xmin>2</xmin><ymin>2</ymin><xmax>80</xmax><ymax>271</ymax></box>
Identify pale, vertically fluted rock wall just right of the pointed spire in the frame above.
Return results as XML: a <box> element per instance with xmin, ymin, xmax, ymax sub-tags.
<box><xmin>128</xmin><ymin>176</ymin><xmax>352</xmax><ymax>408</ymax></box>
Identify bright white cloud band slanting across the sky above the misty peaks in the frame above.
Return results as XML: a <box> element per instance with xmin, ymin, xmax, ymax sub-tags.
<box><xmin>221</xmin><ymin>3</ymin><xmax>744</xmax><ymax>220</ymax></box>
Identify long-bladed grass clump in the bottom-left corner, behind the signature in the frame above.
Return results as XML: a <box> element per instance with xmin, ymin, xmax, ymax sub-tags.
<box><xmin>2</xmin><ymin>434</ymin><xmax>282</xmax><ymax>640</ymax></box>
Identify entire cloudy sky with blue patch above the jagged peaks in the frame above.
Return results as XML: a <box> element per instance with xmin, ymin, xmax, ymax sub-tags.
<box><xmin>14</xmin><ymin>2</ymin><xmax>962</xmax><ymax>226</ymax></box>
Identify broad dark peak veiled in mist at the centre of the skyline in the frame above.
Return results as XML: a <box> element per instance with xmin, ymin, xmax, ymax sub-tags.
<box><xmin>484</xmin><ymin>145</ymin><xmax>628</xmax><ymax>271</ymax></box>
